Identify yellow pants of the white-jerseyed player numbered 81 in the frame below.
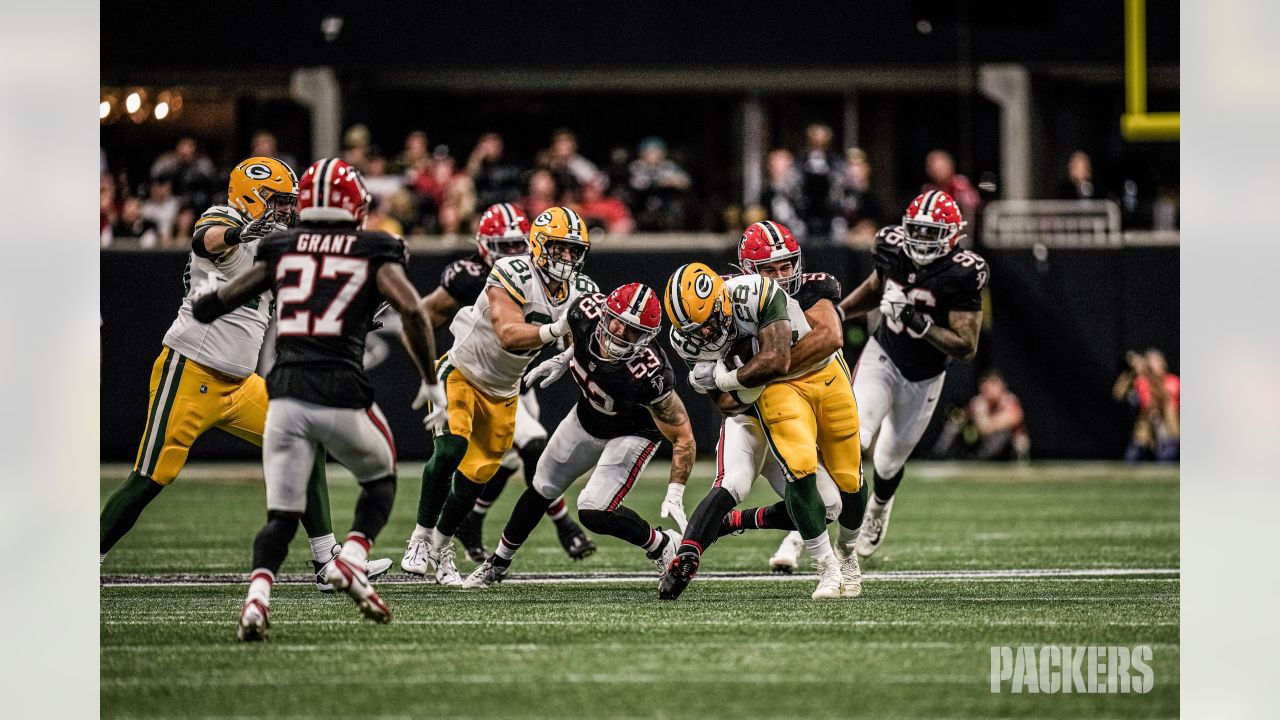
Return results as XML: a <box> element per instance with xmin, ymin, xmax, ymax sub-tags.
<box><xmin>436</xmin><ymin>355</ymin><xmax>519</xmax><ymax>483</ymax></box>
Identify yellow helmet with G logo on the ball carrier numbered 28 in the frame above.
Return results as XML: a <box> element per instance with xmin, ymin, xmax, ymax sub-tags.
<box><xmin>663</xmin><ymin>263</ymin><xmax>735</xmax><ymax>352</ymax></box>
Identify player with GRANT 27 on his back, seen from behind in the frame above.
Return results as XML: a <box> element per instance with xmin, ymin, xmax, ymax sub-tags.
<box><xmin>192</xmin><ymin>158</ymin><xmax>445</xmax><ymax>641</ymax></box>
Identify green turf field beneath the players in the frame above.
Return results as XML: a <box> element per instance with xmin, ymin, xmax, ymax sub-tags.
<box><xmin>101</xmin><ymin>464</ymin><xmax>1179</xmax><ymax>717</ymax></box>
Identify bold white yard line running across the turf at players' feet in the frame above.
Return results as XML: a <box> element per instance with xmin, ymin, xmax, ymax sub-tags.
<box><xmin>101</xmin><ymin>568</ymin><xmax>1181</xmax><ymax>588</ymax></box>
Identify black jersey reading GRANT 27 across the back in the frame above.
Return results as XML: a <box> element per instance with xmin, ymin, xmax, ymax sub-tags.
<box><xmin>257</xmin><ymin>223</ymin><xmax>408</xmax><ymax>407</ymax></box>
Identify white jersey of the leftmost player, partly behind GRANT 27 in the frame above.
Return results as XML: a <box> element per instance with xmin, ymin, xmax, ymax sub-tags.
<box><xmin>164</xmin><ymin>205</ymin><xmax>274</xmax><ymax>378</ymax></box>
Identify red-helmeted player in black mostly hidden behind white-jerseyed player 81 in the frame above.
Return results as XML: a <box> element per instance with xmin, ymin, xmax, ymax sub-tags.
<box><xmin>401</xmin><ymin>202</ymin><xmax>595</xmax><ymax>561</ymax></box>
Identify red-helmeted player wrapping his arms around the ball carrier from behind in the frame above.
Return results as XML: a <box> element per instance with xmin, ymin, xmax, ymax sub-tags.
<box><xmin>713</xmin><ymin>220</ymin><xmax>870</xmax><ymax>584</ymax></box>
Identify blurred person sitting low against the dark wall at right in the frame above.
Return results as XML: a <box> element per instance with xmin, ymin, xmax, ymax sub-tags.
<box><xmin>933</xmin><ymin>370</ymin><xmax>1032</xmax><ymax>460</ymax></box>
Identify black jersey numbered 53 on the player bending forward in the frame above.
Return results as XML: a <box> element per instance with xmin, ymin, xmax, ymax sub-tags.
<box><xmin>568</xmin><ymin>292</ymin><xmax>676</xmax><ymax>441</ymax></box>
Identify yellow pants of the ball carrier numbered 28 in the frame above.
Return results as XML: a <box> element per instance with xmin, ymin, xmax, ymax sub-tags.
<box><xmin>755</xmin><ymin>355</ymin><xmax>863</xmax><ymax>492</ymax></box>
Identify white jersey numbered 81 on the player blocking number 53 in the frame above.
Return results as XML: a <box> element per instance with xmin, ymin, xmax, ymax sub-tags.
<box><xmin>445</xmin><ymin>255</ymin><xmax>599</xmax><ymax>398</ymax></box>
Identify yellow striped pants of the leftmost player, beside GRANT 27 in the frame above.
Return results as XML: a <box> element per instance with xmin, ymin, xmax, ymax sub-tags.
<box><xmin>133</xmin><ymin>347</ymin><xmax>266</xmax><ymax>486</ymax></box>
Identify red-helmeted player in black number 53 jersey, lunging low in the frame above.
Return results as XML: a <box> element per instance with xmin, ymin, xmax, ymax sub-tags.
<box><xmin>462</xmin><ymin>283</ymin><xmax>696</xmax><ymax>588</ymax></box>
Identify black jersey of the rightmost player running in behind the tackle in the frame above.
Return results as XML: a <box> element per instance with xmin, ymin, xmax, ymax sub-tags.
<box><xmin>873</xmin><ymin>225</ymin><xmax>989</xmax><ymax>382</ymax></box>
